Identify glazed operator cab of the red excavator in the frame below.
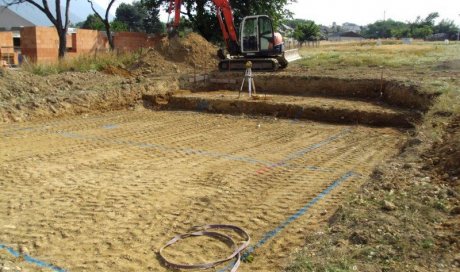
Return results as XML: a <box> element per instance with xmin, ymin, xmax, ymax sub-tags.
<box><xmin>240</xmin><ymin>15</ymin><xmax>283</xmax><ymax>57</ymax></box>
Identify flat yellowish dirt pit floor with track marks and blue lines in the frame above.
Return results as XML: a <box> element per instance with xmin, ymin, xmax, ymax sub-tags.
<box><xmin>0</xmin><ymin>110</ymin><xmax>404</xmax><ymax>271</ymax></box>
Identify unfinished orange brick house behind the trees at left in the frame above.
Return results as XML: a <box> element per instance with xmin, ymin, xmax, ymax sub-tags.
<box><xmin>0</xmin><ymin>6</ymin><xmax>161</xmax><ymax>66</ymax></box>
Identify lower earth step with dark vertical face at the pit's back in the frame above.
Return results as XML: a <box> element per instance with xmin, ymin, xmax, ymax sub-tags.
<box><xmin>144</xmin><ymin>91</ymin><xmax>421</xmax><ymax>128</ymax></box>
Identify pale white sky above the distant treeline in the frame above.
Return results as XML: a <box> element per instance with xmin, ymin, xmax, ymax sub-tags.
<box><xmin>96</xmin><ymin>0</ymin><xmax>460</xmax><ymax>25</ymax></box>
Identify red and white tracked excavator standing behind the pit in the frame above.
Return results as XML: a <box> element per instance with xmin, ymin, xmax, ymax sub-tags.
<box><xmin>168</xmin><ymin>0</ymin><xmax>300</xmax><ymax>71</ymax></box>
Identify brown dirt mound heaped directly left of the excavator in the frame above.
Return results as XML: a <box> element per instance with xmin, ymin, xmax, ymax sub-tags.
<box><xmin>131</xmin><ymin>33</ymin><xmax>218</xmax><ymax>74</ymax></box>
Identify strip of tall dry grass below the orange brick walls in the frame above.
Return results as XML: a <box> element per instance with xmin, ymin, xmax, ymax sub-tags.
<box><xmin>22</xmin><ymin>51</ymin><xmax>142</xmax><ymax>76</ymax></box>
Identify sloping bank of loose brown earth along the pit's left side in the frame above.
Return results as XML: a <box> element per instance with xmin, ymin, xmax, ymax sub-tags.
<box><xmin>0</xmin><ymin>67</ymin><xmax>147</xmax><ymax>123</ymax></box>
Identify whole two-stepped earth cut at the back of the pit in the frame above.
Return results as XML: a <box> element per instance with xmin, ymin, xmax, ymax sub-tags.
<box><xmin>143</xmin><ymin>73</ymin><xmax>436</xmax><ymax>128</ymax></box>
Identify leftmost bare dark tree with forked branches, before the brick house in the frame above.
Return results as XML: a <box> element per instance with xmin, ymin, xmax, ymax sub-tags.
<box><xmin>4</xmin><ymin>0</ymin><xmax>70</xmax><ymax>59</ymax></box>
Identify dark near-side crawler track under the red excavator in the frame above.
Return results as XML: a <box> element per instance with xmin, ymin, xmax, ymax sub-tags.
<box><xmin>219</xmin><ymin>58</ymin><xmax>284</xmax><ymax>72</ymax></box>
